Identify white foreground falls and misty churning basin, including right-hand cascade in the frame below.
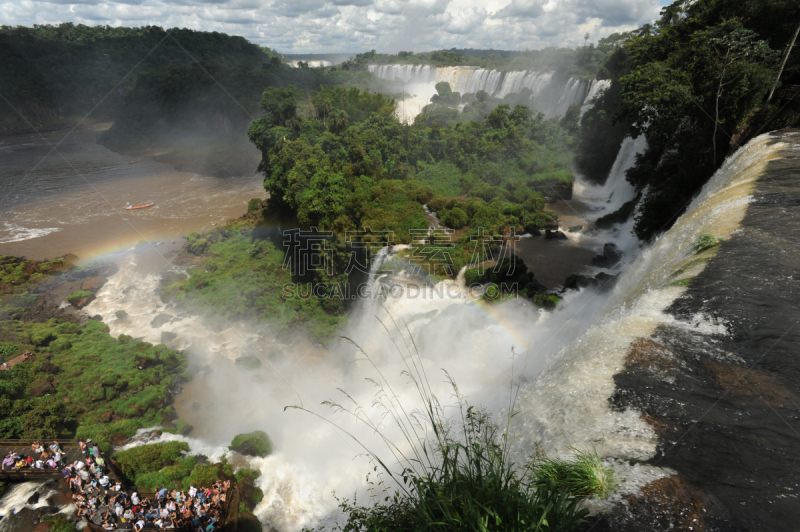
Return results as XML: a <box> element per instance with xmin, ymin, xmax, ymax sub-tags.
<box><xmin>73</xmin><ymin>131</ymin><xmax>780</xmax><ymax>531</ymax></box>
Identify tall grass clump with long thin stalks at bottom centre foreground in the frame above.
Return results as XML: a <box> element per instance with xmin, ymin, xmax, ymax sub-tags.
<box><xmin>297</xmin><ymin>330</ymin><xmax>615</xmax><ymax>532</ymax></box>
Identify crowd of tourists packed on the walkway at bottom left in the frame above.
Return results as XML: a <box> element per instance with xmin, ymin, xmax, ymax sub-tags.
<box><xmin>3</xmin><ymin>439</ymin><xmax>231</xmax><ymax>532</ymax></box>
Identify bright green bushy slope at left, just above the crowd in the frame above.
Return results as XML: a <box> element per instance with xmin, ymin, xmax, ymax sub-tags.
<box><xmin>0</xmin><ymin>318</ymin><xmax>186</xmax><ymax>449</ymax></box>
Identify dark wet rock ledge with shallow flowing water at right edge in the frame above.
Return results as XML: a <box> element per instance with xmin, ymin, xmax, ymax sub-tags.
<box><xmin>608</xmin><ymin>140</ymin><xmax>800</xmax><ymax>532</ymax></box>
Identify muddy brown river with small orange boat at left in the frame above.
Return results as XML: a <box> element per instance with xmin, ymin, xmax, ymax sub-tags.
<box><xmin>0</xmin><ymin>124</ymin><xmax>266</xmax><ymax>261</ymax></box>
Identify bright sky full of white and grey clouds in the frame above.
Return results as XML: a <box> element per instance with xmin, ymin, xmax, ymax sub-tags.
<box><xmin>0</xmin><ymin>0</ymin><xmax>668</xmax><ymax>53</ymax></box>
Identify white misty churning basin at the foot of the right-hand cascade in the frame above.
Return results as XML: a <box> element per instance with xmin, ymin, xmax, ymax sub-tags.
<box><xmin>78</xmin><ymin>127</ymin><xmax>652</xmax><ymax>530</ymax></box>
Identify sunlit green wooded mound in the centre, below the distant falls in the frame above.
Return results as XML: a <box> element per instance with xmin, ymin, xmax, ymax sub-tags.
<box><xmin>249</xmin><ymin>87</ymin><xmax>571</xmax><ymax>237</ymax></box>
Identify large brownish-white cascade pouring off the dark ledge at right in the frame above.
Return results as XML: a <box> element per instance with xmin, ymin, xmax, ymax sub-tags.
<box><xmin>510</xmin><ymin>135</ymin><xmax>786</xmax><ymax>483</ymax></box>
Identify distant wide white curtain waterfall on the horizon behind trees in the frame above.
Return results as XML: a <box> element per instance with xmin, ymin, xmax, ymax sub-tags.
<box><xmin>368</xmin><ymin>65</ymin><xmax>610</xmax><ymax>121</ymax></box>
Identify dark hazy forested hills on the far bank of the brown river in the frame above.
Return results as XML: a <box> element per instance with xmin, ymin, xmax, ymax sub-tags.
<box><xmin>0</xmin><ymin>23</ymin><xmax>382</xmax><ymax>176</ymax></box>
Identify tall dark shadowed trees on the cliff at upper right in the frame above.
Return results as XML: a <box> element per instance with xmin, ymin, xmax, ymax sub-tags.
<box><xmin>578</xmin><ymin>0</ymin><xmax>800</xmax><ymax>239</ymax></box>
